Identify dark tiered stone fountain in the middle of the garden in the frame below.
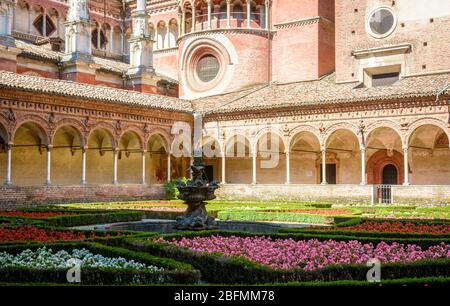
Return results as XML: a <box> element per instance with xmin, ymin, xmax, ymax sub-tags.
<box><xmin>175</xmin><ymin>157</ymin><xmax>219</xmax><ymax>230</ymax></box>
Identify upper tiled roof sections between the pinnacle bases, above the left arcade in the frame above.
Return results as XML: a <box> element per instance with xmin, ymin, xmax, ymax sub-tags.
<box><xmin>15</xmin><ymin>39</ymin><xmax>178</xmax><ymax>83</ymax></box>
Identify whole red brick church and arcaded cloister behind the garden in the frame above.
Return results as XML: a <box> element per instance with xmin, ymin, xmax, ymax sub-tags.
<box><xmin>0</xmin><ymin>0</ymin><xmax>450</xmax><ymax>208</ymax></box>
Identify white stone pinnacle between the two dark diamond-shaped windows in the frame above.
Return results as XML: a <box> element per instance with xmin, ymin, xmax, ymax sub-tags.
<box><xmin>65</xmin><ymin>0</ymin><xmax>92</xmax><ymax>60</ymax></box>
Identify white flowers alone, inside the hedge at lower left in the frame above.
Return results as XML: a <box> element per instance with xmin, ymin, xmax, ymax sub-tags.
<box><xmin>0</xmin><ymin>246</ymin><xmax>163</xmax><ymax>272</ymax></box>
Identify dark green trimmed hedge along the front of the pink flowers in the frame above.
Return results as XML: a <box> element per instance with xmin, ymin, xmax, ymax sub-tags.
<box><xmin>121</xmin><ymin>236</ymin><xmax>450</xmax><ymax>284</ymax></box>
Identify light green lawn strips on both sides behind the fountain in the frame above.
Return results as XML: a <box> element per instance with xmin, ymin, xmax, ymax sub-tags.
<box><xmin>45</xmin><ymin>200</ymin><xmax>450</xmax><ymax>223</ymax></box>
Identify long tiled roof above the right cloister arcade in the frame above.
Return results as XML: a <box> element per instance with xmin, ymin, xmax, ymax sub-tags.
<box><xmin>193</xmin><ymin>73</ymin><xmax>450</xmax><ymax>114</ymax></box>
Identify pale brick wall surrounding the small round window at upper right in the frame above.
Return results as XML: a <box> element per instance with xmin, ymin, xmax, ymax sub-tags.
<box><xmin>336</xmin><ymin>0</ymin><xmax>450</xmax><ymax>82</ymax></box>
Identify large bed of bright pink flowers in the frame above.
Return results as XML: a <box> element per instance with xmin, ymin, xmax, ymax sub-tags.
<box><xmin>157</xmin><ymin>236</ymin><xmax>450</xmax><ymax>271</ymax></box>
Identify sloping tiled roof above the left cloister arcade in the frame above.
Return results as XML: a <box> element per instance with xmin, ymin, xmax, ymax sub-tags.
<box><xmin>0</xmin><ymin>71</ymin><xmax>192</xmax><ymax>113</ymax></box>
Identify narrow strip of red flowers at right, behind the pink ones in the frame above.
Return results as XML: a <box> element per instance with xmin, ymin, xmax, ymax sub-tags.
<box><xmin>333</xmin><ymin>221</ymin><xmax>450</xmax><ymax>234</ymax></box>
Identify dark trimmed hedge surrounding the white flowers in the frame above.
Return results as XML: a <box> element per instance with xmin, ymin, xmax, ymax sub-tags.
<box><xmin>0</xmin><ymin>242</ymin><xmax>200</xmax><ymax>285</ymax></box>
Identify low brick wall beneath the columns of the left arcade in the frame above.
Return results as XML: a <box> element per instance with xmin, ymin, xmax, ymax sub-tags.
<box><xmin>0</xmin><ymin>185</ymin><xmax>165</xmax><ymax>210</ymax></box>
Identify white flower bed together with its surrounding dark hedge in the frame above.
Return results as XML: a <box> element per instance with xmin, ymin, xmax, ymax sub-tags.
<box><xmin>0</xmin><ymin>242</ymin><xmax>200</xmax><ymax>285</ymax></box>
